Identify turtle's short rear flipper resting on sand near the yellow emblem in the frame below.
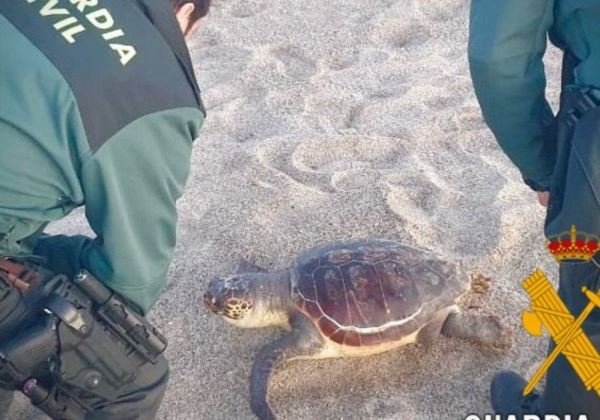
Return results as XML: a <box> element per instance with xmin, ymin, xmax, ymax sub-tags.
<box><xmin>442</xmin><ymin>312</ymin><xmax>512</xmax><ymax>349</ymax></box>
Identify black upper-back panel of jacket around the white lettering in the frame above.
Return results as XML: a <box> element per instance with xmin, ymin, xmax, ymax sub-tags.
<box><xmin>0</xmin><ymin>0</ymin><xmax>203</xmax><ymax>151</ymax></box>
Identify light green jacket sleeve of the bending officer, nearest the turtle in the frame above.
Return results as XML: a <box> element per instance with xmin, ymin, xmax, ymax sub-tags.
<box><xmin>36</xmin><ymin>108</ymin><xmax>202</xmax><ymax>313</ymax></box>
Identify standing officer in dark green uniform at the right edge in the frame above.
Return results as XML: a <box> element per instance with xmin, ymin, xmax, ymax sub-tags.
<box><xmin>469</xmin><ymin>0</ymin><xmax>600</xmax><ymax>419</ymax></box>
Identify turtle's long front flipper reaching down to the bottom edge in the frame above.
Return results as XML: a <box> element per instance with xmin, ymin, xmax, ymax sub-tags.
<box><xmin>250</xmin><ymin>316</ymin><xmax>323</xmax><ymax>420</ymax></box>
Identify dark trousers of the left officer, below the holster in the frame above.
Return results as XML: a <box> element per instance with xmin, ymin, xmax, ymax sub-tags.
<box><xmin>27</xmin><ymin>327</ymin><xmax>169</xmax><ymax>420</ymax></box>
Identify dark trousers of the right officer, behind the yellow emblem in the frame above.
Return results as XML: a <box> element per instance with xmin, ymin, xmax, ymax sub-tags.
<box><xmin>541</xmin><ymin>90</ymin><xmax>600</xmax><ymax>419</ymax></box>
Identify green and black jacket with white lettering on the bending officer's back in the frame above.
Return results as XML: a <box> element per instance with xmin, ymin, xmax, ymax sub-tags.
<box><xmin>0</xmin><ymin>0</ymin><xmax>204</xmax><ymax>312</ymax></box>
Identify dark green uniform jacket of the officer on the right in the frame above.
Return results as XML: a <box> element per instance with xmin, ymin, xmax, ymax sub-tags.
<box><xmin>469</xmin><ymin>0</ymin><xmax>600</xmax><ymax>189</ymax></box>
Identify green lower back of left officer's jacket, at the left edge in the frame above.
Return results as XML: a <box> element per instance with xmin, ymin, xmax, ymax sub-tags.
<box><xmin>0</xmin><ymin>15</ymin><xmax>89</xmax><ymax>255</ymax></box>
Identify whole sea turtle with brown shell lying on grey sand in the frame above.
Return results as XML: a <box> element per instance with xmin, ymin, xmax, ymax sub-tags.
<box><xmin>204</xmin><ymin>240</ymin><xmax>510</xmax><ymax>419</ymax></box>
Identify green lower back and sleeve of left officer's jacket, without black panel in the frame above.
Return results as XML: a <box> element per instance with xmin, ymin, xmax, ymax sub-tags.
<box><xmin>0</xmin><ymin>15</ymin><xmax>202</xmax><ymax>312</ymax></box>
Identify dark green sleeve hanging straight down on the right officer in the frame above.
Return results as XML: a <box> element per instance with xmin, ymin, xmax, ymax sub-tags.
<box><xmin>469</xmin><ymin>0</ymin><xmax>556</xmax><ymax>190</ymax></box>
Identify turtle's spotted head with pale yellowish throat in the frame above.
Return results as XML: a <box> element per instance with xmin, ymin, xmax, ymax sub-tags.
<box><xmin>204</xmin><ymin>273</ymin><xmax>290</xmax><ymax>328</ymax></box>
